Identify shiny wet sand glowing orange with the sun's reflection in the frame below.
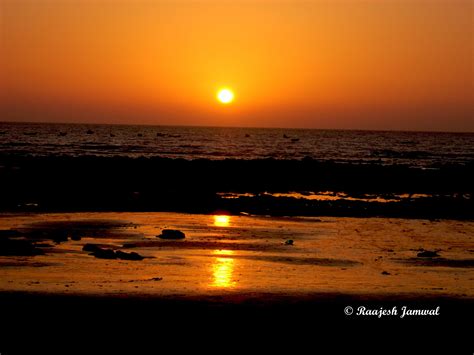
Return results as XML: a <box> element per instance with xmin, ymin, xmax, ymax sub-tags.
<box><xmin>0</xmin><ymin>213</ymin><xmax>474</xmax><ymax>299</ymax></box>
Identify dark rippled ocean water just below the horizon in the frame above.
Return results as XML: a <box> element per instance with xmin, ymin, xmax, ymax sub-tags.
<box><xmin>0</xmin><ymin>123</ymin><xmax>474</xmax><ymax>167</ymax></box>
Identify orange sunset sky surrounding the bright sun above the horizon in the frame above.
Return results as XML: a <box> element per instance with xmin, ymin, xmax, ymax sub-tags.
<box><xmin>0</xmin><ymin>0</ymin><xmax>474</xmax><ymax>132</ymax></box>
